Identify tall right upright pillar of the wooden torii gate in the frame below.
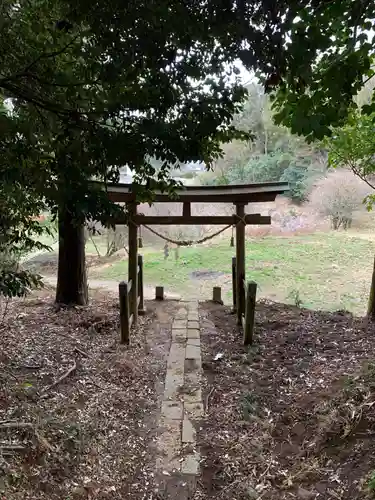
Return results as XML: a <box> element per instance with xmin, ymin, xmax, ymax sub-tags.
<box><xmin>236</xmin><ymin>203</ymin><xmax>245</xmax><ymax>325</ymax></box>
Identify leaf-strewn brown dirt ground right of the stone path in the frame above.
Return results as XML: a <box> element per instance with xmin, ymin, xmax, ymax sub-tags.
<box><xmin>196</xmin><ymin>303</ymin><xmax>375</xmax><ymax>500</ymax></box>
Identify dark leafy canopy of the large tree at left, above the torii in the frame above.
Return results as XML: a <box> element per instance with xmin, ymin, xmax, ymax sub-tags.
<box><xmin>0</xmin><ymin>0</ymin><xmax>288</xmax><ymax>290</ymax></box>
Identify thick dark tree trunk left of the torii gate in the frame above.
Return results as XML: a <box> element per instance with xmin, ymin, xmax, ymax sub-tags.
<box><xmin>56</xmin><ymin>209</ymin><xmax>88</xmax><ymax>306</ymax></box>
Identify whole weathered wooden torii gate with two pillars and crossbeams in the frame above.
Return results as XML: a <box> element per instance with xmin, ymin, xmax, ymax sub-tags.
<box><xmin>107</xmin><ymin>182</ymin><xmax>289</xmax><ymax>324</ymax></box>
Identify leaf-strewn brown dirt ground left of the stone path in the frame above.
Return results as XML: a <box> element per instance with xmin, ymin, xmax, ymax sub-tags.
<box><xmin>0</xmin><ymin>291</ymin><xmax>178</xmax><ymax>500</ymax></box>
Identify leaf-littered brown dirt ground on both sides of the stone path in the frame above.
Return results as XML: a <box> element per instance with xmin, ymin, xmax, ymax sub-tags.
<box><xmin>0</xmin><ymin>290</ymin><xmax>375</xmax><ymax>500</ymax></box>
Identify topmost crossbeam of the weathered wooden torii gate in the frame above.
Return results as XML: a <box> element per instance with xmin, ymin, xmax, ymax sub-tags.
<box><xmin>107</xmin><ymin>182</ymin><xmax>289</xmax><ymax>205</ymax></box>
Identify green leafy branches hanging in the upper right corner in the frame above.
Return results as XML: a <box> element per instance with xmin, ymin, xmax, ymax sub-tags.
<box><xmin>270</xmin><ymin>0</ymin><xmax>375</xmax><ymax>140</ymax></box>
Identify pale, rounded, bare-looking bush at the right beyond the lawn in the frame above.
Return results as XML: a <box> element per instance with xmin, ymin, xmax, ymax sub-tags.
<box><xmin>310</xmin><ymin>170</ymin><xmax>369</xmax><ymax>229</ymax></box>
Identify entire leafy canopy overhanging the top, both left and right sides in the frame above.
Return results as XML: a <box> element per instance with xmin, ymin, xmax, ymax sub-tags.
<box><xmin>0</xmin><ymin>0</ymin><xmax>375</xmax><ymax>296</ymax></box>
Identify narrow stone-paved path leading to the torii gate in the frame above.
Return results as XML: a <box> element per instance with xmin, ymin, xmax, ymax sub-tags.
<box><xmin>156</xmin><ymin>301</ymin><xmax>204</xmax><ymax>500</ymax></box>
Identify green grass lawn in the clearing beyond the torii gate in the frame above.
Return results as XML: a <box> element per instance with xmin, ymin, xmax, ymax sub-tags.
<box><xmin>92</xmin><ymin>233</ymin><xmax>375</xmax><ymax>314</ymax></box>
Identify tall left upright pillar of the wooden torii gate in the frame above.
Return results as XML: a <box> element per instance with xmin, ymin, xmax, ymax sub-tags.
<box><xmin>128</xmin><ymin>203</ymin><xmax>138</xmax><ymax>325</ymax></box>
